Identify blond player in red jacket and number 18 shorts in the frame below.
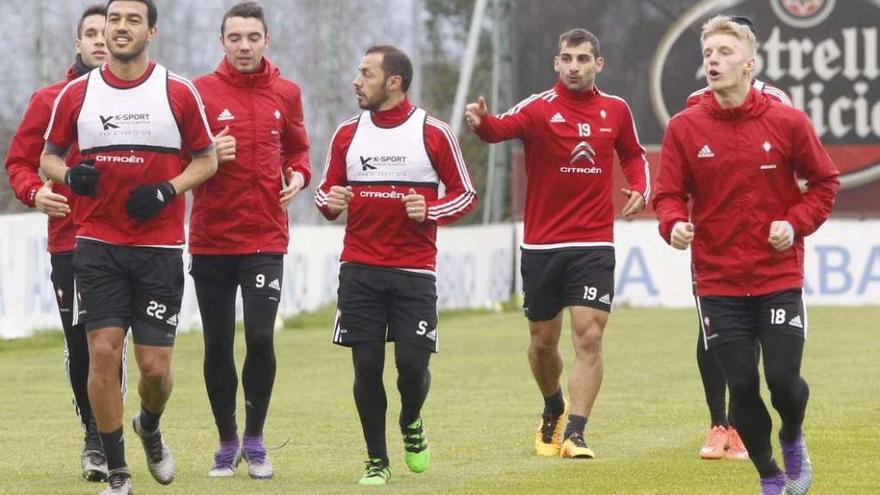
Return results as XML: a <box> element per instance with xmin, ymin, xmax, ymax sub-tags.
<box><xmin>654</xmin><ymin>16</ymin><xmax>839</xmax><ymax>495</ymax></box>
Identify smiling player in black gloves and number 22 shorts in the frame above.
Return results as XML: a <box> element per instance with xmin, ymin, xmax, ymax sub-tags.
<box><xmin>40</xmin><ymin>0</ymin><xmax>217</xmax><ymax>495</ymax></box>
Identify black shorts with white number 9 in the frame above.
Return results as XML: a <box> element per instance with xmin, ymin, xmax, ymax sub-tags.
<box><xmin>189</xmin><ymin>254</ymin><xmax>284</xmax><ymax>298</ymax></box>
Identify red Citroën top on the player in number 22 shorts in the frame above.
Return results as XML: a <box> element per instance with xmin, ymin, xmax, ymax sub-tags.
<box><xmin>45</xmin><ymin>62</ymin><xmax>213</xmax><ymax>247</ymax></box>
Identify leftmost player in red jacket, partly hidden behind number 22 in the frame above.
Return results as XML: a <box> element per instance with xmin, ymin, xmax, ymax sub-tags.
<box><xmin>6</xmin><ymin>5</ymin><xmax>115</xmax><ymax>481</ymax></box>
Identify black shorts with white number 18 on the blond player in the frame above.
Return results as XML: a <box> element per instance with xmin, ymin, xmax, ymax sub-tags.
<box><xmin>697</xmin><ymin>289</ymin><xmax>807</xmax><ymax>349</ymax></box>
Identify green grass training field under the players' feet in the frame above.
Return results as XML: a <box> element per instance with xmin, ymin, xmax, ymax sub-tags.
<box><xmin>0</xmin><ymin>308</ymin><xmax>880</xmax><ymax>495</ymax></box>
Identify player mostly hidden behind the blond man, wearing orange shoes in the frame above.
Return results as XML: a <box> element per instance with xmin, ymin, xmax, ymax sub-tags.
<box><xmin>685</xmin><ymin>16</ymin><xmax>791</xmax><ymax>460</ymax></box>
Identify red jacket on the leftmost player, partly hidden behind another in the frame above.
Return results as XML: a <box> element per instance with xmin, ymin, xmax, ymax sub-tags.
<box><xmin>6</xmin><ymin>66</ymin><xmax>82</xmax><ymax>254</ymax></box>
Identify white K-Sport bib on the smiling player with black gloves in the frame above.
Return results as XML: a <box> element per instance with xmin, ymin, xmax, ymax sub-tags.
<box><xmin>76</xmin><ymin>64</ymin><xmax>181</xmax><ymax>154</ymax></box>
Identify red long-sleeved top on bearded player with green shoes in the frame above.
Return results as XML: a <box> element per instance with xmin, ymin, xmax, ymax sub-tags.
<box><xmin>315</xmin><ymin>100</ymin><xmax>477</xmax><ymax>272</ymax></box>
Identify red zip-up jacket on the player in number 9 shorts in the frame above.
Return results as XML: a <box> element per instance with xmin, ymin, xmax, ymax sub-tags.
<box><xmin>189</xmin><ymin>57</ymin><xmax>311</xmax><ymax>254</ymax></box>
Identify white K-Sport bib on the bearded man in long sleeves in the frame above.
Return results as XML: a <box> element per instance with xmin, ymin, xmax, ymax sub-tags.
<box><xmin>345</xmin><ymin>108</ymin><xmax>440</xmax><ymax>187</ymax></box>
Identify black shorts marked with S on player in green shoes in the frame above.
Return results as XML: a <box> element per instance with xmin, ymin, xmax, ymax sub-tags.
<box><xmin>333</xmin><ymin>263</ymin><xmax>438</xmax><ymax>352</ymax></box>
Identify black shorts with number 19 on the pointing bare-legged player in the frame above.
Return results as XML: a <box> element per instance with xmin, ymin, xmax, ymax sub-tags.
<box><xmin>520</xmin><ymin>247</ymin><xmax>614</xmax><ymax>321</ymax></box>
